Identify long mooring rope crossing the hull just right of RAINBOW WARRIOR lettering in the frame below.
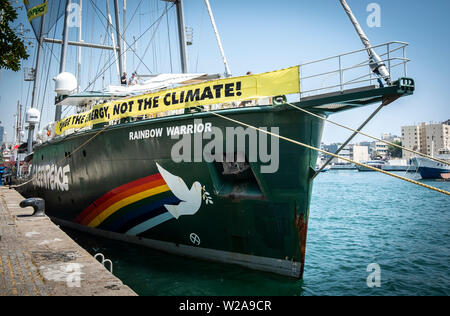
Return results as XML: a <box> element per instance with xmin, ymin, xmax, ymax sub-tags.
<box><xmin>197</xmin><ymin>107</ymin><xmax>450</xmax><ymax>195</ymax></box>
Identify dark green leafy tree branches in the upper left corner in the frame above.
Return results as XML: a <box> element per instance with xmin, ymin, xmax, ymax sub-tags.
<box><xmin>0</xmin><ymin>0</ymin><xmax>29</xmax><ymax>71</ymax></box>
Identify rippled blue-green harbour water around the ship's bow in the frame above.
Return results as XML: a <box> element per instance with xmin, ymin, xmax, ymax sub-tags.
<box><xmin>63</xmin><ymin>170</ymin><xmax>450</xmax><ymax>296</ymax></box>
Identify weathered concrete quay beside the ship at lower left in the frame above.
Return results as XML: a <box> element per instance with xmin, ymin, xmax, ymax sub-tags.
<box><xmin>0</xmin><ymin>186</ymin><xmax>136</xmax><ymax>296</ymax></box>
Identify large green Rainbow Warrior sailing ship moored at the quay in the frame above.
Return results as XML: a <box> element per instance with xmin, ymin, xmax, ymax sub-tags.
<box><xmin>17</xmin><ymin>0</ymin><xmax>414</xmax><ymax>278</ymax></box>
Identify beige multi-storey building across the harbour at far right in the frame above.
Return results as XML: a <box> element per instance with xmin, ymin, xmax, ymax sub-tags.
<box><xmin>402</xmin><ymin>121</ymin><xmax>450</xmax><ymax>159</ymax></box>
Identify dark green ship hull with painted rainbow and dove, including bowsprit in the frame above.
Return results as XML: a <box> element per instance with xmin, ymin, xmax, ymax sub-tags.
<box><xmin>18</xmin><ymin>80</ymin><xmax>413</xmax><ymax>278</ymax></box>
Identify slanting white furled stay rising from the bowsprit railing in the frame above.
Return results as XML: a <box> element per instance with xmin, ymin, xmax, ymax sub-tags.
<box><xmin>340</xmin><ymin>0</ymin><xmax>391</xmax><ymax>85</ymax></box>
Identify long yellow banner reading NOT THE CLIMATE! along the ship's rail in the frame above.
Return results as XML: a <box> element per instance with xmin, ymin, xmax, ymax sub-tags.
<box><xmin>55</xmin><ymin>66</ymin><xmax>300</xmax><ymax>135</ymax></box>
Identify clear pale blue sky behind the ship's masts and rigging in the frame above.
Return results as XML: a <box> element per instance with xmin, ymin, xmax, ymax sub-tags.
<box><xmin>0</xmin><ymin>0</ymin><xmax>450</xmax><ymax>144</ymax></box>
